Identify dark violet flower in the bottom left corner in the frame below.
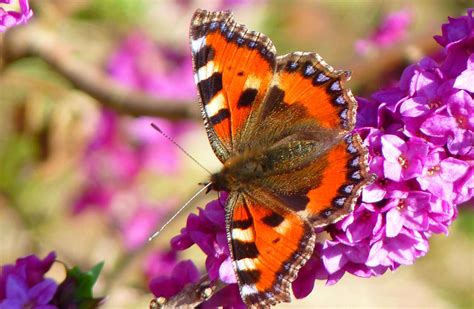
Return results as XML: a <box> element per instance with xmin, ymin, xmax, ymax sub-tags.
<box><xmin>0</xmin><ymin>252</ymin><xmax>57</xmax><ymax>309</ymax></box>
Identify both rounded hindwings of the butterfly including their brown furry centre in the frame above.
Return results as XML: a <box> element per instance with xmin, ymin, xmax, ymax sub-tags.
<box><xmin>244</xmin><ymin>52</ymin><xmax>373</xmax><ymax>226</ymax></box>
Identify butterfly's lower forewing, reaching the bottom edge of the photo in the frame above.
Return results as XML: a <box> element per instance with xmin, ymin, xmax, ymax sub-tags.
<box><xmin>226</xmin><ymin>189</ymin><xmax>316</xmax><ymax>306</ymax></box>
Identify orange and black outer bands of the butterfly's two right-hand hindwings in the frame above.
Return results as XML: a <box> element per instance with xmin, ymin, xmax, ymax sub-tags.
<box><xmin>260</xmin><ymin>52</ymin><xmax>373</xmax><ymax>226</ymax></box>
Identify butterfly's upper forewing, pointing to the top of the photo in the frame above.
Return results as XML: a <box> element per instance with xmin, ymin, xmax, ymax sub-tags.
<box><xmin>190</xmin><ymin>10</ymin><xmax>276</xmax><ymax>162</ymax></box>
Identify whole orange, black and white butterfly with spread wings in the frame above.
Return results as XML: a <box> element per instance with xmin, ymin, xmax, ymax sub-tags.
<box><xmin>190</xmin><ymin>9</ymin><xmax>372</xmax><ymax>306</ymax></box>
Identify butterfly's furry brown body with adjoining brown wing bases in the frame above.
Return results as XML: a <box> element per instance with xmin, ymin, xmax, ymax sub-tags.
<box><xmin>210</xmin><ymin>123</ymin><xmax>344</xmax><ymax>194</ymax></box>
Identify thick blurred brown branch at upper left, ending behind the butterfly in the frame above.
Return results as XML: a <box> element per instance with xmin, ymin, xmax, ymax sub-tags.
<box><xmin>2</xmin><ymin>21</ymin><xmax>201</xmax><ymax>120</ymax></box>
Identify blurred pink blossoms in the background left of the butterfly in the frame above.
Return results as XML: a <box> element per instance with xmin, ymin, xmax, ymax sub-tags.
<box><xmin>74</xmin><ymin>33</ymin><xmax>195</xmax><ymax>250</ymax></box>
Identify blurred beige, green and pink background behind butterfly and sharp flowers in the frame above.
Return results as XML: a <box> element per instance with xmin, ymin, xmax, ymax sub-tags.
<box><xmin>0</xmin><ymin>0</ymin><xmax>474</xmax><ymax>308</ymax></box>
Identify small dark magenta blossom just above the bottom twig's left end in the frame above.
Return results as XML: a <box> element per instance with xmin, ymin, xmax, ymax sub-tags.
<box><xmin>149</xmin><ymin>260</ymin><xmax>199</xmax><ymax>298</ymax></box>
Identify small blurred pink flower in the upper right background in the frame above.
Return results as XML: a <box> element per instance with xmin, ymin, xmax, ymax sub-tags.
<box><xmin>355</xmin><ymin>10</ymin><xmax>412</xmax><ymax>55</ymax></box>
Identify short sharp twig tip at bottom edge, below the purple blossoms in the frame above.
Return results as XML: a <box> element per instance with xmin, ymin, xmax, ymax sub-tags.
<box><xmin>150</xmin><ymin>275</ymin><xmax>225</xmax><ymax>309</ymax></box>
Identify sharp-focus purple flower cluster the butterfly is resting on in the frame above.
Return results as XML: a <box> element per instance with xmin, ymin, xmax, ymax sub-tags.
<box><xmin>151</xmin><ymin>10</ymin><xmax>474</xmax><ymax>306</ymax></box>
